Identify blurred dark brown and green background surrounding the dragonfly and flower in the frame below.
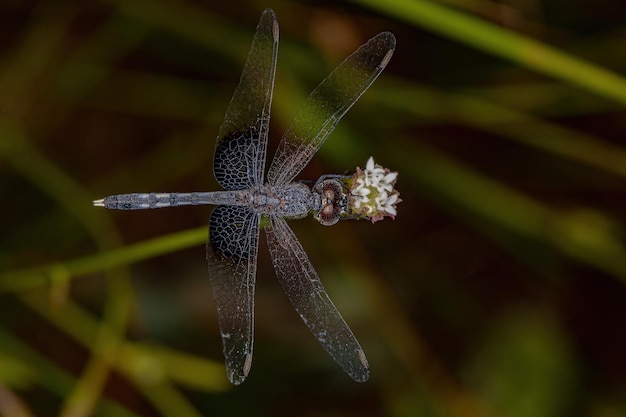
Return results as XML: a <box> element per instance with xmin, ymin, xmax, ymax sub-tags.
<box><xmin>0</xmin><ymin>0</ymin><xmax>626</xmax><ymax>417</ymax></box>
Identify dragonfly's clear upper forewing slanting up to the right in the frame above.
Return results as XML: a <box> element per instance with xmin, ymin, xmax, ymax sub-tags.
<box><xmin>267</xmin><ymin>32</ymin><xmax>396</xmax><ymax>185</ymax></box>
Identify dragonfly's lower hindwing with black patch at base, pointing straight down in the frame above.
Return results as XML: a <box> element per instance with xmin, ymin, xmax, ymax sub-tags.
<box><xmin>207</xmin><ymin>206</ymin><xmax>260</xmax><ymax>384</ymax></box>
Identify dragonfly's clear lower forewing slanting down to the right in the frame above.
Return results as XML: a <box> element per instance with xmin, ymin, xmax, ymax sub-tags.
<box><xmin>265</xmin><ymin>217</ymin><xmax>369</xmax><ymax>382</ymax></box>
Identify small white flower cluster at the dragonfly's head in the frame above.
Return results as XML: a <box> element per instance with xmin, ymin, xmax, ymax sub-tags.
<box><xmin>349</xmin><ymin>157</ymin><xmax>402</xmax><ymax>223</ymax></box>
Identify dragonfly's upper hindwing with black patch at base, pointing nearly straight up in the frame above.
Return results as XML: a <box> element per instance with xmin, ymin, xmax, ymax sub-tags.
<box><xmin>213</xmin><ymin>9</ymin><xmax>278</xmax><ymax>190</ymax></box>
